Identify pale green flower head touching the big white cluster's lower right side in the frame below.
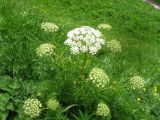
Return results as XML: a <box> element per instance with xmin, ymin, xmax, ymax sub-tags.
<box><xmin>107</xmin><ymin>40</ymin><xmax>122</xmax><ymax>53</ymax></box>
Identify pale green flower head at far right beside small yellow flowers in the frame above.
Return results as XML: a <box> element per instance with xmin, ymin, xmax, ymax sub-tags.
<box><xmin>130</xmin><ymin>76</ymin><xmax>145</xmax><ymax>89</ymax></box>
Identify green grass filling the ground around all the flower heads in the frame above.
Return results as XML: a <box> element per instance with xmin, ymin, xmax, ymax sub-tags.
<box><xmin>0</xmin><ymin>0</ymin><xmax>160</xmax><ymax>120</ymax></box>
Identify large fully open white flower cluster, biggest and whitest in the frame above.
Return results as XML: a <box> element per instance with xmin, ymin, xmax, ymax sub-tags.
<box><xmin>64</xmin><ymin>26</ymin><xmax>105</xmax><ymax>54</ymax></box>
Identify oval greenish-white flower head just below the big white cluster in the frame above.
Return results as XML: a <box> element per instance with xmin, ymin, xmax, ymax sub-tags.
<box><xmin>88</xmin><ymin>68</ymin><xmax>109</xmax><ymax>89</ymax></box>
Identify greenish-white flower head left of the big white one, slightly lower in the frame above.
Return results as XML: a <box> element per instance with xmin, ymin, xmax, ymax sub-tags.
<box><xmin>36</xmin><ymin>43</ymin><xmax>55</xmax><ymax>57</ymax></box>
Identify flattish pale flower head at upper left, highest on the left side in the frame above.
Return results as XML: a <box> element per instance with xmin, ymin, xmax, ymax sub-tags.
<box><xmin>41</xmin><ymin>22</ymin><xmax>59</xmax><ymax>32</ymax></box>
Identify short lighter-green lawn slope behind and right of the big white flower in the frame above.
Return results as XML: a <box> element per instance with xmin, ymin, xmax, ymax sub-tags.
<box><xmin>9</xmin><ymin>0</ymin><xmax>160</xmax><ymax>78</ymax></box>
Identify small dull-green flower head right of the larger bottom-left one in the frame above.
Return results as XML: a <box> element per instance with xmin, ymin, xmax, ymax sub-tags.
<box><xmin>47</xmin><ymin>98</ymin><xmax>60</xmax><ymax>110</ymax></box>
